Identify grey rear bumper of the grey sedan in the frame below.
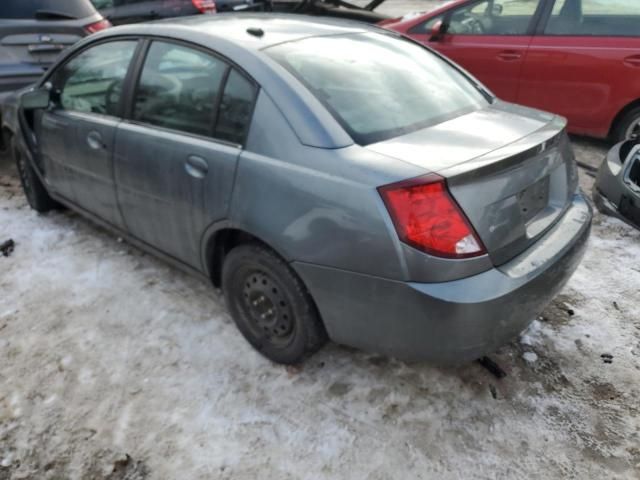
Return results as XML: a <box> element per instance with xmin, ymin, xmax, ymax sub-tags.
<box><xmin>293</xmin><ymin>194</ymin><xmax>592</xmax><ymax>363</ymax></box>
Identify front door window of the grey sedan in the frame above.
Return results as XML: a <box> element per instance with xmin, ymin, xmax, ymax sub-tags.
<box><xmin>53</xmin><ymin>40</ymin><xmax>137</xmax><ymax>116</ymax></box>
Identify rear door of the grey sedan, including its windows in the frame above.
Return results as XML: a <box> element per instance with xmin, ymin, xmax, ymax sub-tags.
<box><xmin>115</xmin><ymin>40</ymin><xmax>256</xmax><ymax>268</ymax></box>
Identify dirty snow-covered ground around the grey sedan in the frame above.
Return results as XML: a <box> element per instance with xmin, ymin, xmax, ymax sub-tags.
<box><xmin>0</xmin><ymin>137</ymin><xmax>640</xmax><ymax>480</ymax></box>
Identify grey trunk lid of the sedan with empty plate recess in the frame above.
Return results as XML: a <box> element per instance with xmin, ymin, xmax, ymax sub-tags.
<box><xmin>367</xmin><ymin>102</ymin><xmax>578</xmax><ymax>266</ymax></box>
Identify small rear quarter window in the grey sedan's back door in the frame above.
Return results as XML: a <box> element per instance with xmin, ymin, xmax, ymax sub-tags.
<box><xmin>215</xmin><ymin>70</ymin><xmax>256</xmax><ymax>144</ymax></box>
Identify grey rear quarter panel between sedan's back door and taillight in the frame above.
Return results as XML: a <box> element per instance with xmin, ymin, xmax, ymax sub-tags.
<box><xmin>225</xmin><ymin>91</ymin><xmax>424</xmax><ymax>279</ymax></box>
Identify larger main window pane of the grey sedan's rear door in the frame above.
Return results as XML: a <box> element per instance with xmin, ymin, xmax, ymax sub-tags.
<box><xmin>133</xmin><ymin>42</ymin><xmax>228</xmax><ymax>136</ymax></box>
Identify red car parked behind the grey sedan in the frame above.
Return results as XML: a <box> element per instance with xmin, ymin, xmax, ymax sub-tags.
<box><xmin>382</xmin><ymin>0</ymin><xmax>640</xmax><ymax>141</ymax></box>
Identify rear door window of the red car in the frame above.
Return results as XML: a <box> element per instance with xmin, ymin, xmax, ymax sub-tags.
<box><xmin>545</xmin><ymin>0</ymin><xmax>640</xmax><ymax>37</ymax></box>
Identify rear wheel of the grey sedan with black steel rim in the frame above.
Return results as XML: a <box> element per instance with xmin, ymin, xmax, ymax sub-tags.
<box><xmin>222</xmin><ymin>243</ymin><xmax>327</xmax><ymax>365</ymax></box>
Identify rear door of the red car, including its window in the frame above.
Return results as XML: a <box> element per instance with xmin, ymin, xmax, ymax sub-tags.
<box><xmin>518</xmin><ymin>0</ymin><xmax>640</xmax><ymax>137</ymax></box>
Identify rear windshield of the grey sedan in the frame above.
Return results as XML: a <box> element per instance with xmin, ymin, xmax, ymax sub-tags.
<box><xmin>265</xmin><ymin>33</ymin><xmax>488</xmax><ymax>145</ymax></box>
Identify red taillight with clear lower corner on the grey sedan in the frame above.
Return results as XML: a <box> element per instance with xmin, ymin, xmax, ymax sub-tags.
<box><xmin>378</xmin><ymin>174</ymin><xmax>486</xmax><ymax>258</ymax></box>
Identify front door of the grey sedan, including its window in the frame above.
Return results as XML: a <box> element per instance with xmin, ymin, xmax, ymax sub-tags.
<box><xmin>36</xmin><ymin>40</ymin><xmax>138</xmax><ymax>227</ymax></box>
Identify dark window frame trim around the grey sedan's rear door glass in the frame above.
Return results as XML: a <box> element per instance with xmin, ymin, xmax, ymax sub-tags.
<box><xmin>122</xmin><ymin>35</ymin><xmax>260</xmax><ymax>148</ymax></box>
